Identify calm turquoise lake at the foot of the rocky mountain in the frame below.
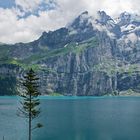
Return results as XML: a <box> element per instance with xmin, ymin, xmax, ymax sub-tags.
<box><xmin>0</xmin><ymin>97</ymin><xmax>140</xmax><ymax>140</ymax></box>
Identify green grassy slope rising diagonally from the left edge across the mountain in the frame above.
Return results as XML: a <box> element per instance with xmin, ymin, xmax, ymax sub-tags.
<box><xmin>0</xmin><ymin>37</ymin><xmax>98</xmax><ymax>70</ymax></box>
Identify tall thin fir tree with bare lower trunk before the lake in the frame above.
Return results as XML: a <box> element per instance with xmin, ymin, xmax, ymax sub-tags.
<box><xmin>18</xmin><ymin>69</ymin><xmax>43</xmax><ymax>140</ymax></box>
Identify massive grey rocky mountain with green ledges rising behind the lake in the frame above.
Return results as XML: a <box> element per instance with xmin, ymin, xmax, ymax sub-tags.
<box><xmin>0</xmin><ymin>11</ymin><xmax>140</xmax><ymax>96</ymax></box>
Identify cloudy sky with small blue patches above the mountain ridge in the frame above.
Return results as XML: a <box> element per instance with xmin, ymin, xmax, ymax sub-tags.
<box><xmin>0</xmin><ymin>0</ymin><xmax>140</xmax><ymax>44</ymax></box>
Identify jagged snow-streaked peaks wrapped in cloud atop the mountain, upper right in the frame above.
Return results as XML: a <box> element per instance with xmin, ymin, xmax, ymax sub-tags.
<box><xmin>68</xmin><ymin>11</ymin><xmax>140</xmax><ymax>39</ymax></box>
